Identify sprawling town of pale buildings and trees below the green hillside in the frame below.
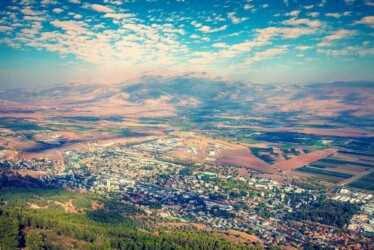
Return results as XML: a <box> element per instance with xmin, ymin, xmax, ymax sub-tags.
<box><xmin>0</xmin><ymin>139</ymin><xmax>374</xmax><ymax>249</ymax></box>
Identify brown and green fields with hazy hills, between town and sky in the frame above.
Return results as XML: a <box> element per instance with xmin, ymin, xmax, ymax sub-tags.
<box><xmin>0</xmin><ymin>78</ymin><xmax>374</xmax><ymax>188</ymax></box>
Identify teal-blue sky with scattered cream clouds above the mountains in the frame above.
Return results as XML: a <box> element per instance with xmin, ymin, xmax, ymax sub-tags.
<box><xmin>0</xmin><ymin>0</ymin><xmax>374</xmax><ymax>88</ymax></box>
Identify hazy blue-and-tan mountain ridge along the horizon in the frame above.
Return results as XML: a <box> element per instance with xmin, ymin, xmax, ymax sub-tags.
<box><xmin>0</xmin><ymin>76</ymin><xmax>374</xmax><ymax>116</ymax></box>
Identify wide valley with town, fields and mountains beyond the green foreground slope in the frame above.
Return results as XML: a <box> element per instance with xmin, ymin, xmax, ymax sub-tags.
<box><xmin>0</xmin><ymin>76</ymin><xmax>374</xmax><ymax>249</ymax></box>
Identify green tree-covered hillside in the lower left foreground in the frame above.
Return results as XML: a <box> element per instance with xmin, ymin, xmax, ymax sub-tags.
<box><xmin>0</xmin><ymin>188</ymin><xmax>253</xmax><ymax>249</ymax></box>
